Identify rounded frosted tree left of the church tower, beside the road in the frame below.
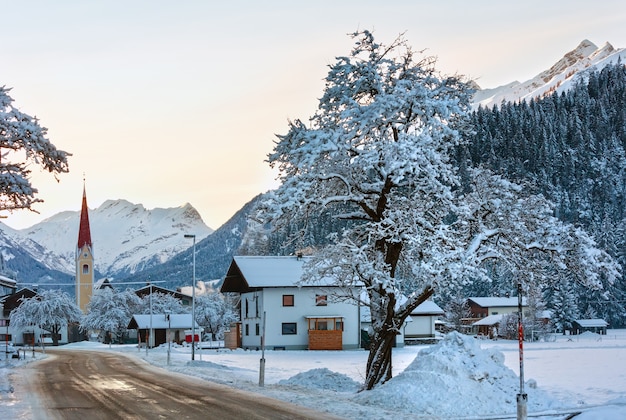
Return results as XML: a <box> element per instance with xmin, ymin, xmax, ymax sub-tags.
<box><xmin>10</xmin><ymin>290</ymin><xmax>83</xmax><ymax>346</ymax></box>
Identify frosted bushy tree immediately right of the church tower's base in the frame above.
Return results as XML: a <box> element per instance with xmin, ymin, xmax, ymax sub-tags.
<box><xmin>81</xmin><ymin>288</ymin><xmax>141</xmax><ymax>340</ymax></box>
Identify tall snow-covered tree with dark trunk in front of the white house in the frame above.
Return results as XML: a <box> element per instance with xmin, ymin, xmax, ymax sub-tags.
<box><xmin>260</xmin><ymin>31</ymin><xmax>616</xmax><ymax>389</ymax></box>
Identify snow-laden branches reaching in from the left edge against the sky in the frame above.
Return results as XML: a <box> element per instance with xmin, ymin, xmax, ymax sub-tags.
<box><xmin>0</xmin><ymin>86</ymin><xmax>70</xmax><ymax>211</ymax></box>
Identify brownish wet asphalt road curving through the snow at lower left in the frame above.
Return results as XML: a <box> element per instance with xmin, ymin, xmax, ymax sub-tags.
<box><xmin>15</xmin><ymin>349</ymin><xmax>336</xmax><ymax>420</ymax></box>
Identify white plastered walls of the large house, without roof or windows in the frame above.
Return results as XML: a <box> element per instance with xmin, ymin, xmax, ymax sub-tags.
<box><xmin>241</xmin><ymin>287</ymin><xmax>359</xmax><ymax>350</ymax></box>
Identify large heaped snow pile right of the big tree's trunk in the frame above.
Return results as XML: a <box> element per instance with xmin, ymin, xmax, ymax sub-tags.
<box><xmin>355</xmin><ymin>332</ymin><xmax>559</xmax><ymax>417</ymax></box>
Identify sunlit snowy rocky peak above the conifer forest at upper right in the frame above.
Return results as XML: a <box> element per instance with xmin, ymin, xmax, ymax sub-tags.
<box><xmin>472</xmin><ymin>39</ymin><xmax>626</xmax><ymax>108</ymax></box>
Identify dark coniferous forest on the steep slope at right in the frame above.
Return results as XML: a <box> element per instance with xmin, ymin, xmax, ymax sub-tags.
<box><xmin>458</xmin><ymin>63</ymin><xmax>626</xmax><ymax>327</ymax></box>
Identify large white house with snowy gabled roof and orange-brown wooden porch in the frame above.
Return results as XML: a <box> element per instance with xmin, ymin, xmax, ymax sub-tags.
<box><xmin>221</xmin><ymin>256</ymin><xmax>360</xmax><ymax>350</ymax></box>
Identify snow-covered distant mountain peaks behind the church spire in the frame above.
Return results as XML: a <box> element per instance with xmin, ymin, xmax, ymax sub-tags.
<box><xmin>11</xmin><ymin>200</ymin><xmax>213</xmax><ymax>277</ymax></box>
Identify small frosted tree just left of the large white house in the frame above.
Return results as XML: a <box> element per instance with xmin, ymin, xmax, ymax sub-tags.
<box><xmin>196</xmin><ymin>291</ymin><xmax>239</xmax><ymax>339</ymax></box>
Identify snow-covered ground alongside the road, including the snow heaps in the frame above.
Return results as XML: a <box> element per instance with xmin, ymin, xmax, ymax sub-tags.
<box><xmin>0</xmin><ymin>330</ymin><xmax>626</xmax><ymax>420</ymax></box>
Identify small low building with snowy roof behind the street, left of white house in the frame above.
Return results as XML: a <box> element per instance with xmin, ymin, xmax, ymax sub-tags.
<box><xmin>128</xmin><ymin>314</ymin><xmax>200</xmax><ymax>347</ymax></box>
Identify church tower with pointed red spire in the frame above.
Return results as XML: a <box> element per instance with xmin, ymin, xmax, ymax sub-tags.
<box><xmin>76</xmin><ymin>185</ymin><xmax>94</xmax><ymax>313</ymax></box>
